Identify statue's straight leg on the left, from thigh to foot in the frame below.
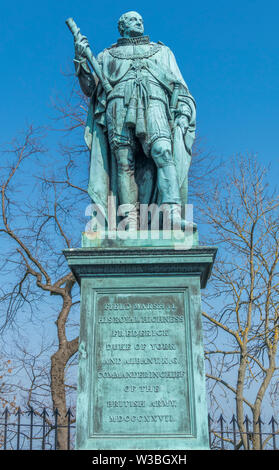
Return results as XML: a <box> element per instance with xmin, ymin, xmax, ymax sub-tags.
<box><xmin>114</xmin><ymin>145</ymin><xmax>138</xmax><ymax>230</ymax></box>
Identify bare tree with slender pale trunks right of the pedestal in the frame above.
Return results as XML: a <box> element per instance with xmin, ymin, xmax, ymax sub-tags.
<box><xmin>203</xmin><ymin>156</ymin><xmax>279</xmax><ymax>449</ymax></box>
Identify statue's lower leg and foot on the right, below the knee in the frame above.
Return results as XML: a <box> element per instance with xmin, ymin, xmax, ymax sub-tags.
<box><xmin>157</xmin><ymin>165</ymin><xmax>197</xmax><ymax>231</ymax></box>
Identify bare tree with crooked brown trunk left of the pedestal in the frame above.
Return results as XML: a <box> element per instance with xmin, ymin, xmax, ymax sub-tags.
<box><xmin>0</xmin><ymin>126</ymin><xmax>88</xmax><ymax>449</ymax></box>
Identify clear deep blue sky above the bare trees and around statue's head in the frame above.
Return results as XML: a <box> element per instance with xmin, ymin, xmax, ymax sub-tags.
<box><xmin>0</xmin><ymin>0</ymin><xmax>279</xmax><ymax>172</ymax></box>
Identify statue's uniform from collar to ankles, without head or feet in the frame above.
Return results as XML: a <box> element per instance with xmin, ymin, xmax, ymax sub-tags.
<box><xmin>76</xmin><ymin>36</ymin><xmax>195</xmax><ymax>222</ymax></box>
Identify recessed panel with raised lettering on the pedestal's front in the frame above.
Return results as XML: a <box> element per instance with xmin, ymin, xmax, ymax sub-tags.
<box><xmin>91</xmin><ymin>289</ymin><xmax>193</xmax><ymax>435</ymax></box>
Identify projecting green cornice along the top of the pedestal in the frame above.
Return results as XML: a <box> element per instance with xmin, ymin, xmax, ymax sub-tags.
<box><xmin>63</xmin><ymin>246</ymin><xmax>217</xmax><ymax>288</ymax></box>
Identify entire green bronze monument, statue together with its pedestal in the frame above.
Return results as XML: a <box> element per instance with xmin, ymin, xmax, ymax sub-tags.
<box><xmin>64</xmin><ymin>12</ymin><xmax>216</xmax><ymax>450</ymax></box>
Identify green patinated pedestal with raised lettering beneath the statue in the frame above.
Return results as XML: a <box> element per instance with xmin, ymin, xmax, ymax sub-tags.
<box><xmin>64</xmin><ymin>233</ymin><xmax>216</xmax><ymax>450</ymax></box>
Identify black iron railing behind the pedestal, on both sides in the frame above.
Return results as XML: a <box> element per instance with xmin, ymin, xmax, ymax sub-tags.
<box><xmin>0</xmin><ymin>407</ymin><xmax>279</xmax><ymax>450</ymax></box>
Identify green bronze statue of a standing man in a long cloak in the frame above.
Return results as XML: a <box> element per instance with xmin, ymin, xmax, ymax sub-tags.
<box><xmin>74</xmin><ymin>12</ymin><xmax>196</xmax><ymax>230</ymax></box>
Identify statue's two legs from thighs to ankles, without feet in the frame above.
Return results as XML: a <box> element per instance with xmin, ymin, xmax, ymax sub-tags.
<box><xmin>106</xmin><ymin>98</ymin><xmax>180</xmax><ymax>204</ymax></box>
